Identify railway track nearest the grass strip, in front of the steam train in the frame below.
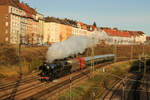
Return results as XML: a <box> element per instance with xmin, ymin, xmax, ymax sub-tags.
<box><xmin>0</xmin><ymin>59</ymin><xmax>113</xmax><ymax>100</ymax></box>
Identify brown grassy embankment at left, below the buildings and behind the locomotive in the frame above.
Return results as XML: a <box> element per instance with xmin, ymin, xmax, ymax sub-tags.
<box><xmin>0</xmin><ymin>44</ymin><xmax>48</xmax><ymax>81</ymax></box>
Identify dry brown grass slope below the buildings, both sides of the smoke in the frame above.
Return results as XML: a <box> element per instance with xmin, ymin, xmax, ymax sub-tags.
<box><xmin>0</xmin><ymin>44</ymin><xmax>150</xmax><ymax>77</ymax></box>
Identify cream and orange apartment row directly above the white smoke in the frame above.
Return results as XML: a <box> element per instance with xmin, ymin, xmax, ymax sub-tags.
<box><xmin>43</xmin><ymin>21</ymin><xmax>99</xmax><ymax>44</ymax></box>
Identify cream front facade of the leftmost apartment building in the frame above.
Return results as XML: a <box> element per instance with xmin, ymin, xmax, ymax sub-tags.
<box><xmin>9</xmin><ymin>6</ymin><xmax>26</xmax><ymax>44</ymax></box>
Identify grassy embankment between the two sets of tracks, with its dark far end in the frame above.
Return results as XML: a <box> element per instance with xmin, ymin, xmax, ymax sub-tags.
<box><xmin>59</xmin><ymin>61</ymin><xmax>142</xmax><ymax>100</ymax></box>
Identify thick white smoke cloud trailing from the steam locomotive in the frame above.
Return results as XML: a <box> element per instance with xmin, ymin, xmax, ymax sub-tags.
<box><xmin>46</xmin><ymin>35</ymin><xmax>99</xmax><ymax>63</ymax></box>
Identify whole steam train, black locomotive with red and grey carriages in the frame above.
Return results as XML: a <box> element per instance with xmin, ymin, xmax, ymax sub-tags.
<box><xmin>39</xmin><ymin>54</ymin><xmax>115</xmax><ymax>81</ymax></box>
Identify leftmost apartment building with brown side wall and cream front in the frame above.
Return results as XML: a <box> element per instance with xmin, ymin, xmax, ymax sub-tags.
<box><xmin>0</xmin><ymin>0</ymin><xmax>25</xmax><ymax>44</ymax></box>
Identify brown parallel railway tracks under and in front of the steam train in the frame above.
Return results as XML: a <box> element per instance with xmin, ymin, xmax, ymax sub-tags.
<box><xmin>0</xmin><ymin>59</ymin><xmax>131</xmax><ymax>100</ymax></box>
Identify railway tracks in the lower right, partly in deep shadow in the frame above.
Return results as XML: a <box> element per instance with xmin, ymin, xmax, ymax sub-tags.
<box><xmin>100</xmin><ymin>62</ymin><xmax>150</xmax><ymax>100</ymax></box>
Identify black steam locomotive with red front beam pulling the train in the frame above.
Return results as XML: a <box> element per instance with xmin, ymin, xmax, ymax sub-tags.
<box><xmin>39</xmin><ymin>61</ymin><xmax>72</xmax><ymax>81</ymax></box>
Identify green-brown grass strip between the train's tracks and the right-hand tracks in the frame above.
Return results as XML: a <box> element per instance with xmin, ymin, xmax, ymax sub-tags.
<box><xmin>59</xmin><ymin>61</ymin><xmax>135</xmax><ymax>100</ymax></box>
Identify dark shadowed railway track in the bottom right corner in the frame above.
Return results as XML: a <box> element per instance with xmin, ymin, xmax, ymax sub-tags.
<box><xmin>126</xmin><ymin>64</ymin><xmax>150</xmax><ymax>100</ymax></box>
